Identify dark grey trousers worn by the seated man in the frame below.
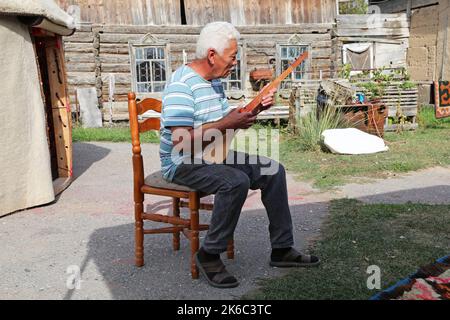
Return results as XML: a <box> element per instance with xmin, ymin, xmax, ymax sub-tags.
<box><xmin>173</xmin><ymin>151</ymin><xmax>294</xmax><ymax>253</ymax></box>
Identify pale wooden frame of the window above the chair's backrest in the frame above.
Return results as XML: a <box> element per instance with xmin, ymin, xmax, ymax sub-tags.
<box><xmin>129</xmin><ymin>34</ymin><xmax>172</xmax><ymax>99</ymax></box>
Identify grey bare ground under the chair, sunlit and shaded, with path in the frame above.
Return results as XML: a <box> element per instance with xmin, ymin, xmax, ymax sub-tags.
<box><xmin>0</xmin><ymin>143</ymin><xmax>450</xmax><ymax>300</ymax></box>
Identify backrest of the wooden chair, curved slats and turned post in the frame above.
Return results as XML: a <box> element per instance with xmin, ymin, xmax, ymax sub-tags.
<box><xmin>128</xmin><ymin>92</ymin><xmax>162</xmax><ymax>188</ymax></box>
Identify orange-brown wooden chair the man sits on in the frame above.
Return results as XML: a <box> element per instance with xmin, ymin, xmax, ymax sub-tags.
<box><xmin>128</xmin><ymin>92</ymin><xmax>234</xmax><ymax>279</ymax></box>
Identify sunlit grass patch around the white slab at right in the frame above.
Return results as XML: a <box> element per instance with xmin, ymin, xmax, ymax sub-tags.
<box><xmin>280</xmin><ymin>108</ymin><xmax>450</xmax><ymax>189</ymax></box>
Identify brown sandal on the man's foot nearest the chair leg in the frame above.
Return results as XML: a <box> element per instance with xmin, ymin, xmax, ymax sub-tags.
<box><xmin>195</xmin><ymin>253</ymin><xmax>239</xmax><ymax>288</ymax></box>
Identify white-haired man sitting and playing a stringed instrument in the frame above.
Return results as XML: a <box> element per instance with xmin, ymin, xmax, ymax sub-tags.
<box><xmin>160</xmin><ymin>22</ymin><xmax>319</xmax><ymax>288</ymax></box>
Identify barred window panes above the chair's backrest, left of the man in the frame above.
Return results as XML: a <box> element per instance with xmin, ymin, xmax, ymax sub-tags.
<box><xmin>133</xmin><ymin>46</ymin><xmax>167</xmax><ymax>93</ymax></box>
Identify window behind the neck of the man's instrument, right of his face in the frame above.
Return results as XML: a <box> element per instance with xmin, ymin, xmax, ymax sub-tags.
<box><xmin>277</xmin><ymin>44</ymin><xmax>309</xmax><ymax>89</ymax></box>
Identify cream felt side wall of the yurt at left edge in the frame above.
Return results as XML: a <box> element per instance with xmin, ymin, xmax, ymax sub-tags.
<box><xmin>0</xmin><ymin>16</ymin><xmax>55</xmax><ymax>216</ymax></box>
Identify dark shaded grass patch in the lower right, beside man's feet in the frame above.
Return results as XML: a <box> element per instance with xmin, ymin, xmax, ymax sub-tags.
<box><xmin>243</xmin><ymin>199</ymin><xmax>450</xmax><ymax>300</ymax></box>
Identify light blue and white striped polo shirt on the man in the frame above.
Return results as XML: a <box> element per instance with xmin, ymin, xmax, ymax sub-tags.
<box><xmin>159</xmin><ymin>65</ymin><xmax>230</xmax><ymax>181</ymax></box>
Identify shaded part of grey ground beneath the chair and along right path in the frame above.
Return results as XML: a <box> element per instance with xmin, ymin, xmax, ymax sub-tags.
<box><xmin>65</xmin><ymin>185</ymin><xmax>450</xmax><ymax>300</ymax></box>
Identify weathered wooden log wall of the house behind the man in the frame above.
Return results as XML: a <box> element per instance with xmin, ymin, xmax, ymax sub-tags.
<box><xmin>59</xmin><ymin>0</ymin><xmax>335</xmax><ymax>117</ymax></box>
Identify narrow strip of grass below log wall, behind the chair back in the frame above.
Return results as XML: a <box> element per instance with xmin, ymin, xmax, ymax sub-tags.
<box><xmin>72</xmin><ymin>125</ymin><xmax>159</xmax><ymax>143</ymax></box>
